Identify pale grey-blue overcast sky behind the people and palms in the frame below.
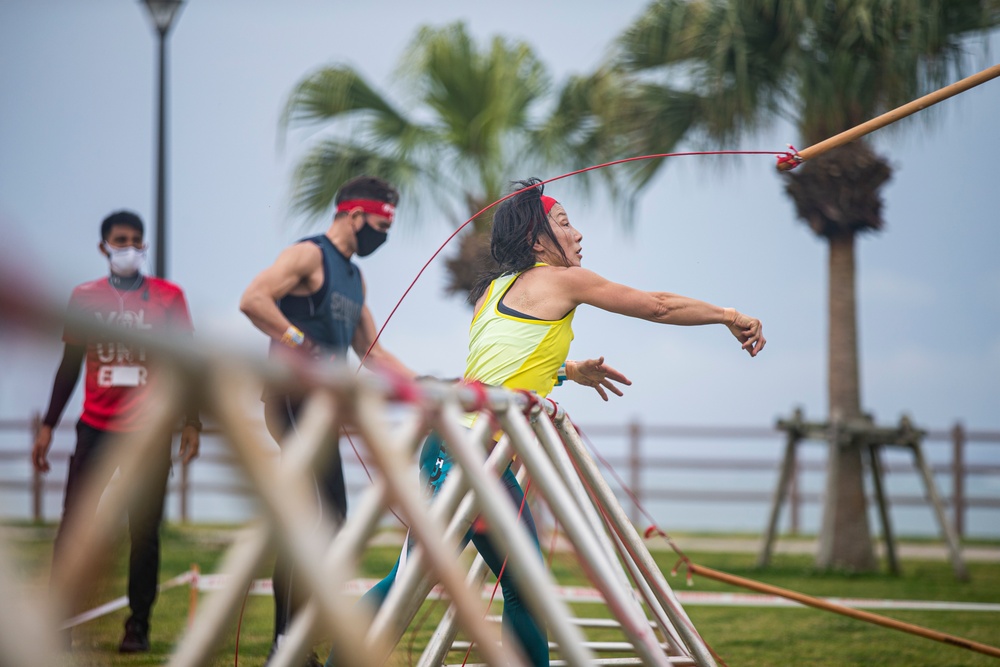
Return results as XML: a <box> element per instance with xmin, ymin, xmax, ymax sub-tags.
<box><xmin>0</xmin><ymin>0</ymin><xmax>1000</xmax><ymax>438</ymax></box>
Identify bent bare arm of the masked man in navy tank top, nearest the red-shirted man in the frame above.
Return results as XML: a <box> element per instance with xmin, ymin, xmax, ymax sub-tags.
<box><xmin>240</xmin><ymin>243</ymin><xmax>323</xmax><ymax>340</ymax></box>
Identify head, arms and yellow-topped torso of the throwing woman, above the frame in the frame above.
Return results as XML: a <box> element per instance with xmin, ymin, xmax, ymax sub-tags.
<box><xmin>465</xmin><ymin>179</ymin><xmax>766</xmax><ymax>398</ymax></box>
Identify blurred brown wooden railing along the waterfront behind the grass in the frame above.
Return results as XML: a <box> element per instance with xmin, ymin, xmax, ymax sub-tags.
<box><xmin>0</xmin><ymin>416</ymin><xmax>1000</xmax><ymax>536</ymax></box>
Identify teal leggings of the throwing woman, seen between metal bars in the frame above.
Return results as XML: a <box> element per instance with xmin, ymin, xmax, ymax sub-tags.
<box><xmin>326</xmin><ymin>433</ymin><xmax>549</xmax><ymax>667</ymax></box>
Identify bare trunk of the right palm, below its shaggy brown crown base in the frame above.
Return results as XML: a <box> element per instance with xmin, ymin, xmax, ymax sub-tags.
<box><xmin>816</xmin><ymin>233</ymin><xmax>878</xmax><ymax>572</ymax></box>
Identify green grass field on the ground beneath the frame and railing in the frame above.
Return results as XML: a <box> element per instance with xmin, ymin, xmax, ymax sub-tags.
<box><xmin>7</xmin><ymin>525</ymin><xmax>1000</xmax><ymax>667</ymax></box>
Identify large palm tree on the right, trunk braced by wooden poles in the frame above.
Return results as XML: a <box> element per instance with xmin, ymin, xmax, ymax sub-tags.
<box><xmin>616</xmin><ymin>0</ymin><xmax>1000</xmax><ymax>571</ymax></box>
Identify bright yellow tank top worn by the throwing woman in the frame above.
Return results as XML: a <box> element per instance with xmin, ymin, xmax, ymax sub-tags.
<box><xmin>465</xmin><ymin>264</ymin><xmax>576</xmax><ymax>397</ymax></box>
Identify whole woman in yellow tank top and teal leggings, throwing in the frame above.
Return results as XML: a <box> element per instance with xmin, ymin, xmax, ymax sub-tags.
<box><xmin>336</xmin><ymin>179</ymin><xmax>766</xmax><ymax>666</ymax></box>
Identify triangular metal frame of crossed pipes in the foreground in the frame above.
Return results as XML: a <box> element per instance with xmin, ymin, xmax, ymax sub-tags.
<box><xmin>0</xmin><ymin>290</ymin><xmax>715</xmax><ymax>667</ymax></box>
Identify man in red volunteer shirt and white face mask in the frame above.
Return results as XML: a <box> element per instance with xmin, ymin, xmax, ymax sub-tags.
<box><xmin>31</xmin><ymin>211</ymin><xmax>201</xmax><ymax>653</ymax></box>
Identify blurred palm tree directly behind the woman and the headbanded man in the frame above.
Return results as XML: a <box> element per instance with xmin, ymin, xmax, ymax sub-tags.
<box><xmin>282</xmin><ymin>23</ymin><xmax>682</xmax><ymax>296</ymax></box>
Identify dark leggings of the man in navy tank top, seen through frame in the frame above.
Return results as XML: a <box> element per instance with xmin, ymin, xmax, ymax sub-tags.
<box><xmin>264</xmin><ymin>395</ymin><xmax>347</xmax><ymax>641</ymax></box>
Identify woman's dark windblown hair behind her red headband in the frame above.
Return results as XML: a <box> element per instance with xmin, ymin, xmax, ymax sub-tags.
<box><xmin>469</xmin><ymin>177</ymin><xmax>569</xmax><ymax>304</ymax></box>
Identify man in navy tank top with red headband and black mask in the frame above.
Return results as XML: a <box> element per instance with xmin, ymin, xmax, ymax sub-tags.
<box><xmin>240</xmin><ymin>176</ymin><xmax>415</xmax><ymax>667</ymax></box>
